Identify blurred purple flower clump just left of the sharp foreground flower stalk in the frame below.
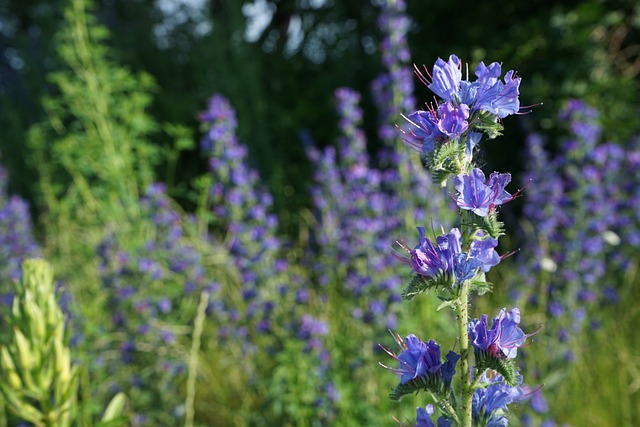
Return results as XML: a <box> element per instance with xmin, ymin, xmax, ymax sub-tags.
<box><xmin>307</xmin><ymin>88</ymin><xmax>412</xmax><ymax>328</ymax></box>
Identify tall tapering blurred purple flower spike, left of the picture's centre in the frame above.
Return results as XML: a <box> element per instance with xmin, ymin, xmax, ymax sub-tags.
<box><xmin>197</xmin><ymin>94</ymin><xmax>338</xmax><ymax>424</ymax></box>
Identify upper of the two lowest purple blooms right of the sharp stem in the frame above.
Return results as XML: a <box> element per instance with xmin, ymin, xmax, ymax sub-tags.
<box><xmin>469</xmin><ymin>308</ymin><xmax>530</xmax><ymax>359</ymax></box>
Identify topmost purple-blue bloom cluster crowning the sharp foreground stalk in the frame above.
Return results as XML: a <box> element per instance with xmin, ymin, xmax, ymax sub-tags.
<box><xmin>401</xmin><ymin>55</ymin><xmax>520</xmax><ymax>184</ymax></box>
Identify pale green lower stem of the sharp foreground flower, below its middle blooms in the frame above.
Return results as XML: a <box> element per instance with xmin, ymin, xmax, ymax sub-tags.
<box><xmin>456</xmin><ymin>283</ymin><xmax>473</xmax><ymax>427</ymax></box>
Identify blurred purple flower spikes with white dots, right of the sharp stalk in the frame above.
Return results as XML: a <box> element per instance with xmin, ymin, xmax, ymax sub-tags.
<box><xmin>512</xmin><ymin>99</ymin><xmax>640</xmax><ymax>424</ymax></box>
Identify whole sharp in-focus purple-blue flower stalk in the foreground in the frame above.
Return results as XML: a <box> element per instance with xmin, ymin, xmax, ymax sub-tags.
<box><xmin>383</xmin><ymin>55</ymin><xmax>531</xmax><ymax>427</ymax></box>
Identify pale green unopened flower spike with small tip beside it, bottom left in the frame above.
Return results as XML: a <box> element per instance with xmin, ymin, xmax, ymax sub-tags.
<box><xmin>0</xmin><ymin>259</ymin><xmax>125</xmax><ymax>427</ymax></box>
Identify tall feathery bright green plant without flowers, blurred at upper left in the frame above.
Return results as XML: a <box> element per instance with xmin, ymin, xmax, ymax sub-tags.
<box><xmin>28</xmin><ymin>0</ymin><xmax>165</xmax><ymax>308</ymax></box>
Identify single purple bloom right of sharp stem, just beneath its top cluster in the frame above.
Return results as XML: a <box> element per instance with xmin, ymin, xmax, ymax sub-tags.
<box><xmin>454</xmin><ymin>168</ymin><xmax>514</xmax><ymax>216</ymax></box>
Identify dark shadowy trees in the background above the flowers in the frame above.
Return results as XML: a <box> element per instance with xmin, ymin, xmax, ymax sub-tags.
<box><xmin>0</xmin><ymin>0</ymin><xmax>640</xmax><ymax>232</ymax></box>
